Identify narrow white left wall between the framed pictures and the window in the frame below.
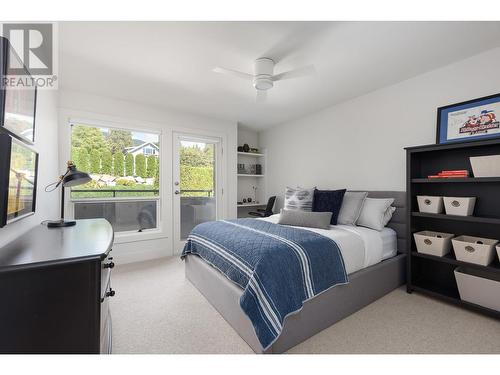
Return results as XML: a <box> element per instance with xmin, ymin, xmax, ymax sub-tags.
<box><xmin>0</xmin><ymin>89</ymin><xmax>61</xmax><ymax>247</ymax></box>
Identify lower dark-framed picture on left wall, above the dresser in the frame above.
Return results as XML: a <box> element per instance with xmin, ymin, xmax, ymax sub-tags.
<box><xmin>0</xmin><ymin>133</ymin><xmax>38</xmax><ymax>228</ymax></box>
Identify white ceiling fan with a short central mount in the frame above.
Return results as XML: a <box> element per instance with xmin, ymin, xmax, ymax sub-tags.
<box><xmin>213</xmin><ymin>57</ymin><xmax>316</xmax><ymax>102</ymax></box>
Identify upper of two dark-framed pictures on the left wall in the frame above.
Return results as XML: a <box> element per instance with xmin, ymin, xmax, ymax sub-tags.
<box><xmin>0</xmin><ymin>38</ymin><xmax>37</xmax><ymax>144</ymax></box>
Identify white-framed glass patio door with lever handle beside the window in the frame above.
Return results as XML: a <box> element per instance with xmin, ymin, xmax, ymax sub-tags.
<box><xmin>172</xmin><ymin>133</ymin><xmax>222</xmax><ymax>253</ymax></box>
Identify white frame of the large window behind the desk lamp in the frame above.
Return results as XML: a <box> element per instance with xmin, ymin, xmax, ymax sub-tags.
<box><xmin>59</xmin><ymin>116</ymin><xmax>168</xmax><ymax>244</ymax></box>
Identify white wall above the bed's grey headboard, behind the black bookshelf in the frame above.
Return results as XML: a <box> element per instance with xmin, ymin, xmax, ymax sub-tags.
<box><xmin>259</xmin><ymin>48</ymin><xmax>500</xmax><ymax>209</ymax></box>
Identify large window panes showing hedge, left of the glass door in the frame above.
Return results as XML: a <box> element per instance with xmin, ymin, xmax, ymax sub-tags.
<box><xmin>71</xmin><ymin>123</ymin><xmax>160</xmax><ymax>232</ymax></box>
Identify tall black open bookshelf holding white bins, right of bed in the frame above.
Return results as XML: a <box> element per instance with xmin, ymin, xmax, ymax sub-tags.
<box><xmin>406</xmin><ymin>140</ymin><xmax>500</xmax><ymax>318</ymax></box>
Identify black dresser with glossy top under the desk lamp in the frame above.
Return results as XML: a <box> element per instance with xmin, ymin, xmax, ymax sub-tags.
<box><xmin>0</xmin><ymin>219</ymin><xmax>115</xmax><ymax>354</ymax></box>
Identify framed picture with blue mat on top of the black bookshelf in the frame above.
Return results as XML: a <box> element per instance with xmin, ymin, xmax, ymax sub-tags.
<box><xmin>436</xmin><ymin>94</ymin><xmax>500</xmax><ymax>144</ymax></box>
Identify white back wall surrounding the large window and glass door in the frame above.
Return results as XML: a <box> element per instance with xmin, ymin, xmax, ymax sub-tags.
<box><xmin>59</xmin><ymin>90</ymin><xmax>237</xmax><ymax>263</ymax></box>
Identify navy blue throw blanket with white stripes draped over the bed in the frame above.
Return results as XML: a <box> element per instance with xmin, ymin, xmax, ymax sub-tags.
<box><xmin>181</xmin><ymin>219</ymin><xmax>348</xmax><ymax>350</ymax></box>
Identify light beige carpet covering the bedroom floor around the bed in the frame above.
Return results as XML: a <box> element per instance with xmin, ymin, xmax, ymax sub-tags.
<box><xmin>111</xmin><ymin>258</ymin><xmax>500</xmax><ymax>353</ymax></box>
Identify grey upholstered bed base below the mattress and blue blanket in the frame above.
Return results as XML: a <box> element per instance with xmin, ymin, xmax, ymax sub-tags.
<box><xmin>185</xmin><ymin>254</ymin><xmax>406</xmax><ymax>353</ymax></box>
